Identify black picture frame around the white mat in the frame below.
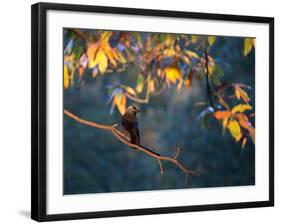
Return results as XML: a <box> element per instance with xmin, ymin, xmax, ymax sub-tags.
<box><xmin>31</xmin><ymin>3</ymin><xmax>274</xmax><ymax>221</ymax></box>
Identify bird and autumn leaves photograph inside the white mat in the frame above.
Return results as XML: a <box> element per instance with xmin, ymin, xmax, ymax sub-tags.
<box><xmin>63</xmin><ymin>27</ymin><xmax>256</xmax><ymax>195</ymax></box>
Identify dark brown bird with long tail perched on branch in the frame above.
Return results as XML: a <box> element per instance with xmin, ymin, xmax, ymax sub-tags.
<box><xmin>121</xmin><ymin>106</ymin><xmax>160</xmax><ymax>156</ymax></box>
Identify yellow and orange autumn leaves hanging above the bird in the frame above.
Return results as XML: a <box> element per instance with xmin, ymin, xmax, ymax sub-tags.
<box><xmin>63</xmin><ymin>29</ymin><xmax>255</xmax><ymax>147</ymax></box>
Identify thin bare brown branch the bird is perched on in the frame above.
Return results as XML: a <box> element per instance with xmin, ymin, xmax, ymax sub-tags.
<box><xmin>64</xmin><ymin>109</ymin><xmax>199</xmax><ymax>176</ymax></box>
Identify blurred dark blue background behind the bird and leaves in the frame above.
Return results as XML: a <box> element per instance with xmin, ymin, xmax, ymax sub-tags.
<box><xmin>64</xmin><ymin>32</ymin><xmax>255</xmax><ymax>194</ymax></box>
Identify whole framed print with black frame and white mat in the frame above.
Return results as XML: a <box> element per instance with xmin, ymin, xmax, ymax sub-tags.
<box><xmin>31</xmin><ymin>3</ymin><xmax>274</xmax><ymax>221</ymax></box>
